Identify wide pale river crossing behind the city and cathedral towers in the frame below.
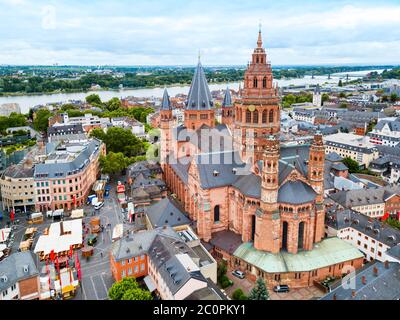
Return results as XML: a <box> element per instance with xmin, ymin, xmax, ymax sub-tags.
<box><xmin>0</xmin><ymin>70</ymin><xmax>382</xmax><ymax>113</ymax></box>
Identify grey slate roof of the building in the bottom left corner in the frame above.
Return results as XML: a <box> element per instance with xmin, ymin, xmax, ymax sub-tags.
<box><xmin>0</xmin><ymin>251</ymin><xmax>39</xmax><ymax>291</ymax></box>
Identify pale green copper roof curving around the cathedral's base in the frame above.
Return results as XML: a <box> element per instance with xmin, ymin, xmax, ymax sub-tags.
<box><xmin>233</xmin><ymin>237</ymin><xmax>364</xmax><ymax>273</ymax></box>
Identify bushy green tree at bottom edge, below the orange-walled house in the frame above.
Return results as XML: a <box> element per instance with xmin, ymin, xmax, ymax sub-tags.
<box><xmin>108</xmin><ymin>278</ymin><xmax>152</xmax><ymax>300</ymax></box>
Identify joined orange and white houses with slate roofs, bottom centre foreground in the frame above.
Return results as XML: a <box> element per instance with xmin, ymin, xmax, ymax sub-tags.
<box><xmin>110</xmin><ymin>226</ymin><xmax>222</xmax><ymax>300</ymax></box>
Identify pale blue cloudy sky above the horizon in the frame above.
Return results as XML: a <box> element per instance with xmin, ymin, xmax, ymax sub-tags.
<box><xmin>0</xmin><ymin>0</ymin><xmax>400</xmax><ymax>66</ymax></box>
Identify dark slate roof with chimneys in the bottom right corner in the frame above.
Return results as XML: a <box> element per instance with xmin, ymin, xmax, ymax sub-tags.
<box><xmin>320</xmin><ymin>261</ymin><xmax>400</xmax><ymax>300</ymax></box>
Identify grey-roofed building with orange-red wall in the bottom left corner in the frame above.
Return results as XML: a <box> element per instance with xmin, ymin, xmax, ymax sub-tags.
<box><xmin>0</xmin><ymin>251</ymin><xmax>40</xmax><ymax>300</ymax></box>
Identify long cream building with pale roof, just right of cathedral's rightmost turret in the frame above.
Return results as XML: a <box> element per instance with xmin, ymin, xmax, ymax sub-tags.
<box><xmin>324</xmin><ymin>132</ymin><xmax>379</xmax><ymax>167</ymax></box>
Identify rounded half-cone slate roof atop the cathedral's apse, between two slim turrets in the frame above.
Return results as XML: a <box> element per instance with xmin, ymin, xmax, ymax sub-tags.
<box><xmin>278</xmin><ymin>181</ymin><xmax>317</xmax><ymax>204</ymax></box>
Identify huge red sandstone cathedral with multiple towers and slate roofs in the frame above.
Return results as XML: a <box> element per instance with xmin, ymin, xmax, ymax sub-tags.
<box><xmin>160</xmin><ymin>30</ymin><xmax>363</xmax><ymax>287</ymax></box>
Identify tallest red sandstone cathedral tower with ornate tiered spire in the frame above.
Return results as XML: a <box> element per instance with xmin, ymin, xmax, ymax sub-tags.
<box><xmin>233</xmin><ymin>29</ymin><xmax>280</xmax><ymax>163</ymax></box>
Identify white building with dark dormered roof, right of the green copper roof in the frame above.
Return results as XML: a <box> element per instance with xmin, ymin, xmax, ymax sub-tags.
<box><xmin>326</xmin><ymin>206</ymin><xmax>400</xmax><ymax>262</ymax></box>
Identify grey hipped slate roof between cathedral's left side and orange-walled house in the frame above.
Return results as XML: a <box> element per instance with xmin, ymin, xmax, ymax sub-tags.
<box><xmin>146</xmin><ymin>198</ymin><xmax>191</xmax><ymax>228</ymax></box>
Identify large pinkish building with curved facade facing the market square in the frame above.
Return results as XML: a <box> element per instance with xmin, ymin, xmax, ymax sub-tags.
<box><xmin>34</xmin><ymin>139</ymin><xmax>106</xmax><ymax>211</ymax></box>
